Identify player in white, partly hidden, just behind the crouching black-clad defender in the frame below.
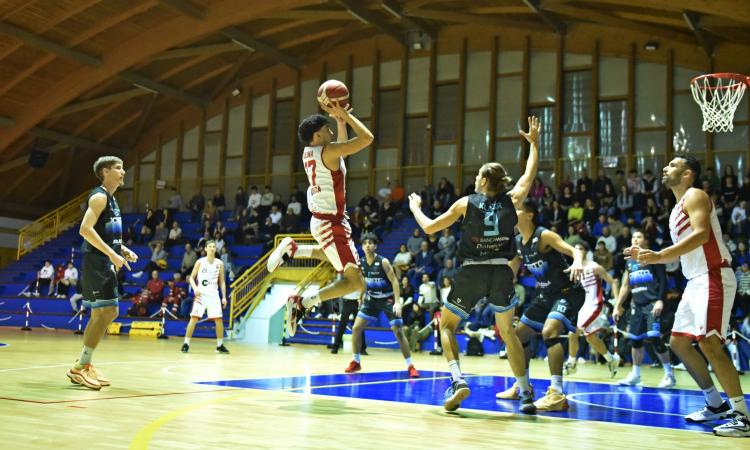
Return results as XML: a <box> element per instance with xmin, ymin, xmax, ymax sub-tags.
<box><xmin>563</xmin><ymin>255</ymin><xmax>620</xmax><ymax>378</ymax></box>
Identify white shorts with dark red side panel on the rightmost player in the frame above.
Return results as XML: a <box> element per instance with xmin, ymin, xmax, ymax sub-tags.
<box><xmin>672</xmin><ymin>267</ymin><xmax>737</xmax><ymax>341</ymax></box>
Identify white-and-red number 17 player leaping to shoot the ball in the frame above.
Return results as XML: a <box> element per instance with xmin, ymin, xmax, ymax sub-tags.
<box><xmin>267</xmin><ymin>104</ymin><xmax>374</xmax><ymax>336</ymax></box>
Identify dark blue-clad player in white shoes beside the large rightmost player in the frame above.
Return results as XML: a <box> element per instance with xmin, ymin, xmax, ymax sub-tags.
<box><xmin>612</xmin><ymin>231</ymin><xmax>677</xmax><ymax>388</ymax></box>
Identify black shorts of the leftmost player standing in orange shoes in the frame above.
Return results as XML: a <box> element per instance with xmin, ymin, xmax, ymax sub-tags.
<box><xmin>81</xmin><ymin>253</ymin><xmax>120</xmax><ymax>308</ymax></box>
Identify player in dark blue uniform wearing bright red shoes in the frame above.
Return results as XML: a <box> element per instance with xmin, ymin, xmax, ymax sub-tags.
<box><xmin>344</xmin><ymin>235</ymin><xmax>419</xmax><ymax>378</ymax></box>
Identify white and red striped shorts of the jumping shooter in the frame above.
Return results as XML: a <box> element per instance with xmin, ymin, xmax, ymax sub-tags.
<box><xmin>310</xmin><ymin>217</ymin><xmax>360</xmax><ymax>273</ymax></box>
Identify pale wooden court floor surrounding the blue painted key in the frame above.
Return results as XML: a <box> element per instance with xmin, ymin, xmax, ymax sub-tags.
<box><xmin>0</xmin><ymin>328</ymin><xmax>748</xmax><ymax>450</ymax></box>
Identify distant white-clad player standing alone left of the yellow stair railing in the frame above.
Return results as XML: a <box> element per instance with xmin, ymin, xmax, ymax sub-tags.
<box><xmin>182</xmin><ymin>241</ymin><xmax>229</xmax><ymax>353</ymax></box>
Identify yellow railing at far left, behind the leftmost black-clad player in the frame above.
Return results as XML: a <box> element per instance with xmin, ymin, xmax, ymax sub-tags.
<box><xmin>16</xmin><ymin>192</ymin><xmax>89</xmax><ymax>259</ymax></box>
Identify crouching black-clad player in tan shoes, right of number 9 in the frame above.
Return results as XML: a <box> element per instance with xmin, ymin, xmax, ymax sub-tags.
<box><xmin>497</xmin><ymin>199</ymin><xmax>586</xmax><ymax>413</ymax></box>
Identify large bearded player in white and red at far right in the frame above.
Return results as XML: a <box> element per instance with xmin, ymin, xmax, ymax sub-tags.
<box><xmin>625</xmin><ymin>156</ymin><xmax>750</xmax><ymax>437</ymax></box>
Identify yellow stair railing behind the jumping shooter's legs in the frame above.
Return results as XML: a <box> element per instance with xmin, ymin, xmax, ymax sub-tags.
<box><xmin>229</xmin><ymin>234</ymin><xmax>330</xmax><ymax>329</ymax></box>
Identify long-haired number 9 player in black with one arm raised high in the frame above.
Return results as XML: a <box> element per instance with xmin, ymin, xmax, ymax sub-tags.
<box><xmin>409</xmin><ymin>117</ymin><xmax>541</xmax><ymax>411</ymax></box>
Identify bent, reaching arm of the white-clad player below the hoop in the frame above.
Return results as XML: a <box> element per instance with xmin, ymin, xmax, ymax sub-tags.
<box><xmin>638</xmin><ymin>189</ymin><xmax>713</xmax><ymax>264</ymax></box>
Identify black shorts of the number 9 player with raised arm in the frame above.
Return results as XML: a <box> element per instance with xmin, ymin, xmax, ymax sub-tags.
<box><xmin>443</xmin><ymin>264</ymin><xmax>518</xmax><ymax>320</ymax></box>
